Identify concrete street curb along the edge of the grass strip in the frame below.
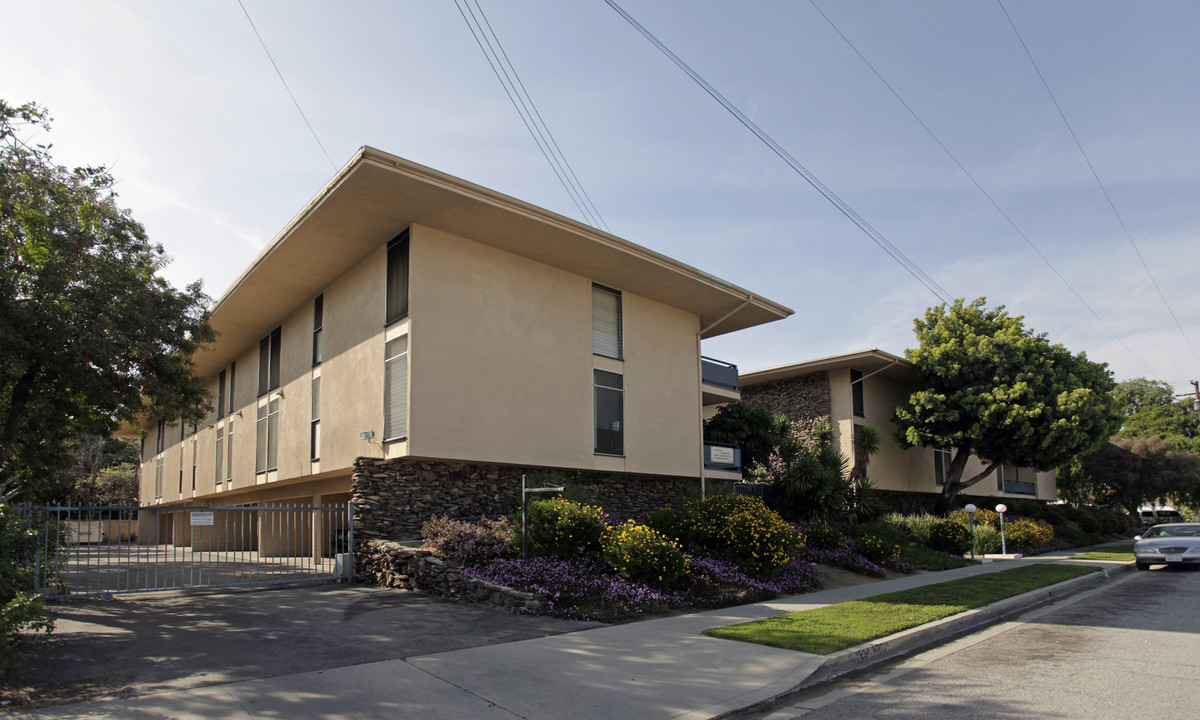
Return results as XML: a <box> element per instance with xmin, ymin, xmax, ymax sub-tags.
<box><xmin>791</xmin><ymin>563</ymin><xmax>1133</xmax><ymax>691</ymax></box>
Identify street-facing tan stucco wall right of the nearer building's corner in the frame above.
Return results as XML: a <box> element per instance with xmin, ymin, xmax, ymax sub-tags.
<box><xmin>408</xmin><ymin>226</ymin><xmax>700</xmax><ymax>475</ymax></box>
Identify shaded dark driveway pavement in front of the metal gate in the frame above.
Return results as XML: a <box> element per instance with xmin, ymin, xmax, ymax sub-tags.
<box><xmin>6</xmin><ymin>584</ymin><xmax>599</xmax><ymax>701</ymax></box>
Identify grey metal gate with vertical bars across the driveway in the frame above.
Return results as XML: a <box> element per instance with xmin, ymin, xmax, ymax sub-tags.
<box><xmin>22</xmin><ymin>503</ymin><xmax>354</xmax><ymax>598</ymax></box>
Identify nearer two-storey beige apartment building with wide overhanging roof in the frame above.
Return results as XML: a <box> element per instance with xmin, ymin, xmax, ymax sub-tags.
<box><xmin>140</xmin><ymin>148</ymin><xmax>791</xmax><ymax>539</ymax></box>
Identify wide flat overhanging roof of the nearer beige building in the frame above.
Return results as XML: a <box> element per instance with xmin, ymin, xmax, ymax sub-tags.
<box><xmin>196</xmin><ymin>148</ymin><xmax>792</xmax><ymax>376</ymax></box>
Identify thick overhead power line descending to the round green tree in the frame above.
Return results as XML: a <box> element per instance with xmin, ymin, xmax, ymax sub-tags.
<box><xmin>605</xmin><ymin>0</ymin><xmax>954</xmax><ymax>304</ymax></box>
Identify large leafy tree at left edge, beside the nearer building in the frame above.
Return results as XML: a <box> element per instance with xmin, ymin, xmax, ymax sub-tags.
<box><xmin>0</xmin><ymin>101</ymin><xmax>212</xmax><ymax>498</ymax></box>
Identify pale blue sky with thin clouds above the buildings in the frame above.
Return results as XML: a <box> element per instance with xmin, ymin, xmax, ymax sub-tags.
<box><xmin>0</xmin><ymin>0</ymin><xmax>1200</xmax><ymax>392</ymax></box>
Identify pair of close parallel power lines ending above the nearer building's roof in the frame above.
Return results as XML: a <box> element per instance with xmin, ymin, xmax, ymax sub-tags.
<box><xmin>455</xmin><ymin>0</ymin><xmax>612</xmax><ymax>233</ymax></box>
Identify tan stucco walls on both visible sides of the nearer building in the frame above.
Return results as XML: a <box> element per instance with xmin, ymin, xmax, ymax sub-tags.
<box><xmin>142</xmin><ymin>220</ymin><xmax>701</xmax><ymax>503</ymax></box>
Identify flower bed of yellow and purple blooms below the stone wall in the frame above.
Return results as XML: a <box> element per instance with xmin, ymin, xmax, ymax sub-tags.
<box><xmin>412</xmin><ymin>494</ymin><xmax>911</xmax><ymax>622</ymax></box>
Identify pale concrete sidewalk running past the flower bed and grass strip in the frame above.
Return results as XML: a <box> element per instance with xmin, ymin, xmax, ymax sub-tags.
<box><xmin>24</xmin><ymin>550</ymin><xmax>1132</xmax><ymax>720</ymax></box>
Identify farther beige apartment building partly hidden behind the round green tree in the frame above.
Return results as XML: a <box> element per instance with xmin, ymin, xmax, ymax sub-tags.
<box><xmin>740</xmin><ymin>349</ymin><xmax>1056</xmax><ymax>502</ymax></box>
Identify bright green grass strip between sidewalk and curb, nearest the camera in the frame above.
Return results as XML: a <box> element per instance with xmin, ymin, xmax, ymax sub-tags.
<box><xmin>703</xmin><ymin>563</ymin><xmax>1099</xmax><ymax>655</ymax></box>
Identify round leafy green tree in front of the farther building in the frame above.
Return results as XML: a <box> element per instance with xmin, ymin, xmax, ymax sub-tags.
<box><xmin>894</xmin><ymin>298</ymin><xmax>1121</xmax><ymax>512</ymax></box>
